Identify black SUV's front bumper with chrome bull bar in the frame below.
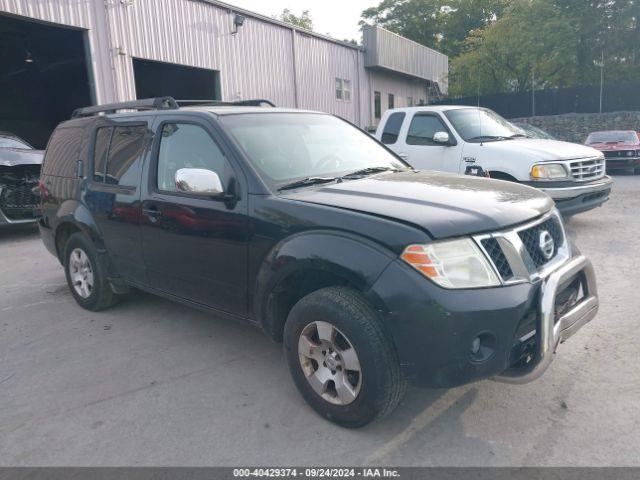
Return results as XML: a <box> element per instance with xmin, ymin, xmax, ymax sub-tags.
<box><xmin>369</xmin><ymin>256</ymin><xmax>598</xmax><ymax>388</ymax></box>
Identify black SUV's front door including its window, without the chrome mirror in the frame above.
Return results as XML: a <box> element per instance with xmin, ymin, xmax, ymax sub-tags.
<box><xmin>141</xmin><ymin>115</ymin><xmax>249</xmax><ymax>315</ymax></box>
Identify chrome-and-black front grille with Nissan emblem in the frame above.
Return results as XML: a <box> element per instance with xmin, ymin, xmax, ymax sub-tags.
<box><xmin>476</xmin><ymin>212</ymin><xmax>569</xmax><ymax>283</ymax></box>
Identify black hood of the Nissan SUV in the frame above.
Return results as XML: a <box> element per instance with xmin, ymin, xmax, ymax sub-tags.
<box><xmin>281</xmin><ymin>172</ymin><xmax>553</xmax><ymax>239</ymax></box>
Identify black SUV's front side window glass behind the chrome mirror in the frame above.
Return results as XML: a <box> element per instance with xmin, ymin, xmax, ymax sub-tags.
<box><xmin>157</xmin><ymin>123</ymin><xmax>231</xmax><ymax>192</ymax></box>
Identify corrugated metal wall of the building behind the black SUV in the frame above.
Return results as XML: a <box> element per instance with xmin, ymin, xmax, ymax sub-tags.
<box><xmin>0</xmin><ymin>0</ymin><xmax>446</xmax><ymax>126</ymax></box>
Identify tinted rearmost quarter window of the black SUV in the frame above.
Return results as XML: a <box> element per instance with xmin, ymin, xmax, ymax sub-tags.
<box><xmin>42</xmin><ymin>127</ymin><xmax>84</xmax><ymax>178</ymax></box>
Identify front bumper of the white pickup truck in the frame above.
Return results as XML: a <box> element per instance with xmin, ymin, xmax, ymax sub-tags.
<box><xmin>530</xmin><ymin>176</ymin><xmax>613</xmax><ymax>215</ymax></box>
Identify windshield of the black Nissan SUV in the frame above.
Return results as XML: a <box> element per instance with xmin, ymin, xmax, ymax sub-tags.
<box><xmin>220</xmin><ymin>113</ymin><xmax>409</xmax><ymax>187</ymax></box>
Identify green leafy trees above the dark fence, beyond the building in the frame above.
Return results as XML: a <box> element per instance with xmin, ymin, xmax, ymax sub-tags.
<box><xmin>362</xmin><ymin>0</ymin><xmax>640</xmax><ymax>96</ymax></box>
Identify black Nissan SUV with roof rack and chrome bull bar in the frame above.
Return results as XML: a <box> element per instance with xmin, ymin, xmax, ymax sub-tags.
<box><xmin>39</xmin><ymin>98</ymin><xmax>598</xmax><ymax>427</ymax></box>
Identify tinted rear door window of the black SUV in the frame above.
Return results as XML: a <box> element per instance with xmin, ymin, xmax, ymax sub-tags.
<box><xmin>105</xmin><ymin>125</ymin><xmax>147</xmax><ymax>187</ymax></box>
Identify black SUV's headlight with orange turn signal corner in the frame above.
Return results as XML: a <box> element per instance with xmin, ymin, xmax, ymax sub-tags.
<box><xmin>401</xmin><ymin>238</ymin><xmax>500</xmax><ymax>288</ymax></box>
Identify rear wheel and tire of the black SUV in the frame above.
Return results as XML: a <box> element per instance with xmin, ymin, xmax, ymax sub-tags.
<box><xmin>64</xmin><ymin>232</ymin><xmax>117</xmax><ymax>312</ymax></box>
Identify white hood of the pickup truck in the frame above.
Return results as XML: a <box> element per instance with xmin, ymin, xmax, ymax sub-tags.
<box><xmin>482</xmin><ymin>138</ymin><xmax>600</xmax><ymax>162</ymax></box>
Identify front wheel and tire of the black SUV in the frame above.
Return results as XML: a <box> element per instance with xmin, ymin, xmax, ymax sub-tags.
<box><xmin>284</xmin><ymin>287</ymin><xmax>406</xmax><ymax>428</ymax></box>
